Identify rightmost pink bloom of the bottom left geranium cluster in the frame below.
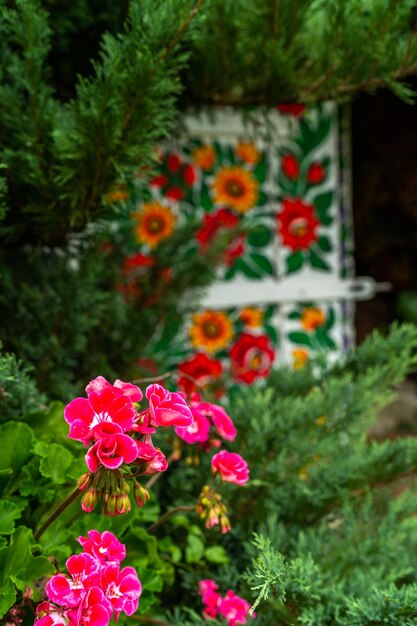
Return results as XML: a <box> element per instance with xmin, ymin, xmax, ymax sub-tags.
<box><xmin>101</xmin><ymin>564</ymin><xmax>142</xmax><ymax>620</ymax></box>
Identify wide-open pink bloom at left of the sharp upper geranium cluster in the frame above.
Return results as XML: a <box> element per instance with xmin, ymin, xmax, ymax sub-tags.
<box><xmin>64</xmin><ymin>386</ymin><xmax>136</xmax><ymax>445</ymax></box>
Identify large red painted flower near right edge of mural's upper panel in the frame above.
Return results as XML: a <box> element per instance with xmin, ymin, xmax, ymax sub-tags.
<box><xmin>278</xmin><ymin>198</ymin><xmax>320</xmax><ymax>250</ymax></box>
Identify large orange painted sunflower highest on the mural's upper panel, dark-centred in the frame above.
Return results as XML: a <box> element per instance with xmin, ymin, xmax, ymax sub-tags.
<box><xmin>213</xmin><ymin>166</ymin><xmax>258</xmax><ymax>213</ymax></box>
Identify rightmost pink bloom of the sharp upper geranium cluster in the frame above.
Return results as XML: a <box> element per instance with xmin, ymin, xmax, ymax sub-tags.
<box><xmin>145</xmin><ymin>384</ymin><xmax>193</xmax><ymax>428</ymax></box>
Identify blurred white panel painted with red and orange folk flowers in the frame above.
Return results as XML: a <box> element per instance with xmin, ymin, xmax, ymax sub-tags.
<box><xmin>108</xmin><ymin>103</ymin><xmax>353</xmax><ymax>394</ymax></box>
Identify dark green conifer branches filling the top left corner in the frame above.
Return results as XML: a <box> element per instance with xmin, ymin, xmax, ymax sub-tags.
<box><xmin>0</xmin><ymin>0</ymin><xmax>198</xmax><ymax>244</ymax></box>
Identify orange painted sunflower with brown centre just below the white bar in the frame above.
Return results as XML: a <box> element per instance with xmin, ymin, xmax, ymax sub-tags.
<box><xmin>190</xmin><ymin>311</ymin><xmax>233</xmax><ymax>352</ymax></box>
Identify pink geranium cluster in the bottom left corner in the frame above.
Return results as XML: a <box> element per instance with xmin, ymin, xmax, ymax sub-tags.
<box><xmin>35</xmin><ymin>530</ymin><xmax>142</xmax><ymax>626</ymax></box>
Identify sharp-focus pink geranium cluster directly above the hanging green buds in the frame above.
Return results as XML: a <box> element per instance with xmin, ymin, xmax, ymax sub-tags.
<box><xmin>64</xmin><ymin>376</ymin><xmax>193</xmax><ymax>474</ymax></box>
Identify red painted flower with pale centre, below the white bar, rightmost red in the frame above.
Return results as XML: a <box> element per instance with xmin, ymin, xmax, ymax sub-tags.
<box><xmin>229</xmin><ymin>333</ymin><xmax>275</xmax><ymax>384</ymax></box>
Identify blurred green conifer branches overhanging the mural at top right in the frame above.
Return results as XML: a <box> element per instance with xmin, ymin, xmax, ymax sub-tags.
<box><xmin>187</xmin><ymin>0</ymin><xmax>417</xmax><ymax>105</ymax></box>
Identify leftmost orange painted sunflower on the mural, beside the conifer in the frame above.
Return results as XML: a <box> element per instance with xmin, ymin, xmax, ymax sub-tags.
<box><xmin>133</xmin><ymin>202</ymin><xmax>176</xmax><ymax>248</ymax></box>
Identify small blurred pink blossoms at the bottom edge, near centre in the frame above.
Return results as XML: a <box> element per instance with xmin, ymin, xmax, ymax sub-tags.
<box><xmin>199</xmin><ymin>579</ymin><xmax>255</xmax><ymax>626</ymax></box>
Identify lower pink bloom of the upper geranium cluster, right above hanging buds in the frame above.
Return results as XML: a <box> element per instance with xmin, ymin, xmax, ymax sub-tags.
<box><xmin>85</xmin><ymin>422</ymin><xmax>138</xmax><ymax>472</ymax></box>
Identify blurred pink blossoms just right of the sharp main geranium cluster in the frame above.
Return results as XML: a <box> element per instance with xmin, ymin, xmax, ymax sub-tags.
<box><xmin>175</xmin><ymin>393</ymin><xmax>236</xmax><ymax>449</ymax></box>
